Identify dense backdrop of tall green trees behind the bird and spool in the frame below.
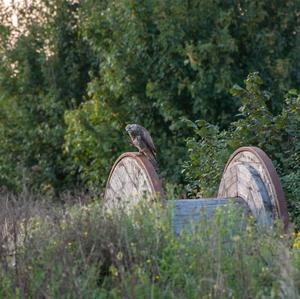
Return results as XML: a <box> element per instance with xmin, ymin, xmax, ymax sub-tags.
<box><xmin>0</xmin><ymin>0</ymin><xmax>300</xmax><ymax>195</ymax></box>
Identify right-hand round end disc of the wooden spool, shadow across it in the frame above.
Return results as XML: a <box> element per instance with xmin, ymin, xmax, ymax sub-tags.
<box><xmin>218</xmin><ymin>147</ymin><xmax>288</xmax><ymax>230</ymax></box>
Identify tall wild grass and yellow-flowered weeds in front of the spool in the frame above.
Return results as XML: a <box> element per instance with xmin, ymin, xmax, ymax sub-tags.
<box><xmin>0</xmin><ymin>194</ymin><xmax>300</xmax><ymax>299</ymax></box>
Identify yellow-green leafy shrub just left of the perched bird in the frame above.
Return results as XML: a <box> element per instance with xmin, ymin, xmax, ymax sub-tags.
<box><xmin>64</xmin><ymin>98</ymin><xmax>129</xmax><ymax>192</ymax></box>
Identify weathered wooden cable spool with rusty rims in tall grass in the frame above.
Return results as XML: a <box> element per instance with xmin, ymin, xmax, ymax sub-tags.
<box><xmin>104</xmin><ymin>147</ymin><xmax>289</xmax><ymax>232</ymax></box>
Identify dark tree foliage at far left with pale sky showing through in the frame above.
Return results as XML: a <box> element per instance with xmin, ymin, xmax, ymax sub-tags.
<box><xmin>0</xmin><ymin>0</ymin><xmax>91</xmax><ymax>192</ymax></box>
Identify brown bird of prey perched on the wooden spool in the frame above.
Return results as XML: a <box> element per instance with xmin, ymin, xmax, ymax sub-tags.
<box><xmin>125</xmin><ymin>124</ymin><xmax>158</xmax><ymax>170</ymax></box>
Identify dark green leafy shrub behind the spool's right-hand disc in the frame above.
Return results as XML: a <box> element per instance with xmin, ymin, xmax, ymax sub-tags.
<box><xmin>184</xmin><ymin>73</ymin><xmax>300</xmax><ymax>227</ymax></box>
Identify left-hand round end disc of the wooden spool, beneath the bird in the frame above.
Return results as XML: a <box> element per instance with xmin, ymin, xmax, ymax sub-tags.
<box><xmin>104</xmin><ymin>153</ymin><xmax>163</xmax><ymax>207</ymax></box>
